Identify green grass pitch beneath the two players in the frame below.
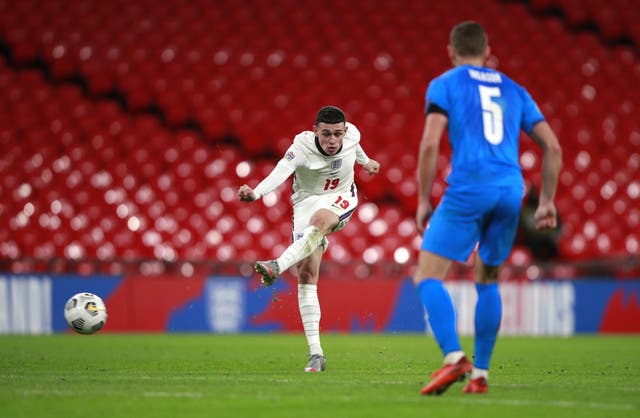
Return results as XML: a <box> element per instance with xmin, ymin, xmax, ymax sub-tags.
<box><xmin>0</xmin><ymin>333</ymin><xmax>640</xmax><ymax>418</ymax></box>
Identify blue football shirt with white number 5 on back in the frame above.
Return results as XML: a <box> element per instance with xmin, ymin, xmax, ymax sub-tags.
<box><xmin>425</xmin><ymin>65</ymin><xmax>544</xmax><ymax>187</ymax></box>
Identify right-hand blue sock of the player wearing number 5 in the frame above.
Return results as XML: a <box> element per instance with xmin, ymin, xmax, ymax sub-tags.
<box><xmin>474</xmin><ymin>283</ymin><xmax>502</xmax><ymax>370</ymax></box>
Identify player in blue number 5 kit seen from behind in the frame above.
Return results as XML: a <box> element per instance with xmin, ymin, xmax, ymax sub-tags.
<box><xmin>414</xmin><ymin>21</ymin><xmax>562</xmax><ymax>395</ymax></box>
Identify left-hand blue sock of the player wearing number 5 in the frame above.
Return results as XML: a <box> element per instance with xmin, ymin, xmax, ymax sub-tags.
<box><xmin>417</xmin><ymin>278</ymin><xmax>462</xmax><ymax>355</ymax></box>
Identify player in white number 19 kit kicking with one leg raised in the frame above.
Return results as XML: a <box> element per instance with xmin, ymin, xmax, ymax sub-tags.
<box><xmin>238</xmin><ymin>106</ymin><xmax>380</xmax><ymax>372</ymax></box>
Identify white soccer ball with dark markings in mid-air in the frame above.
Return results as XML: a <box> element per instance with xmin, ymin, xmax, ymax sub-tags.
<box><xmin>64</xmin><ymin>293</ymin><xmax>107</xmax><ymax>334</ymax></box>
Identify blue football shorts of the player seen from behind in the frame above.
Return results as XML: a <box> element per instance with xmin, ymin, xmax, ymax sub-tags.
<box><xmin>420</xmin><ymin>185</ymin><xmax>523</xmax><ymax>266</ymax></box>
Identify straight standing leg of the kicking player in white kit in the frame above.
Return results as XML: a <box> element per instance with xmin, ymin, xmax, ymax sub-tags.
<box><xmin>296</xmin><ymin>246</ymin><xmax>326</xmax><ymax>372</ymax></box>
